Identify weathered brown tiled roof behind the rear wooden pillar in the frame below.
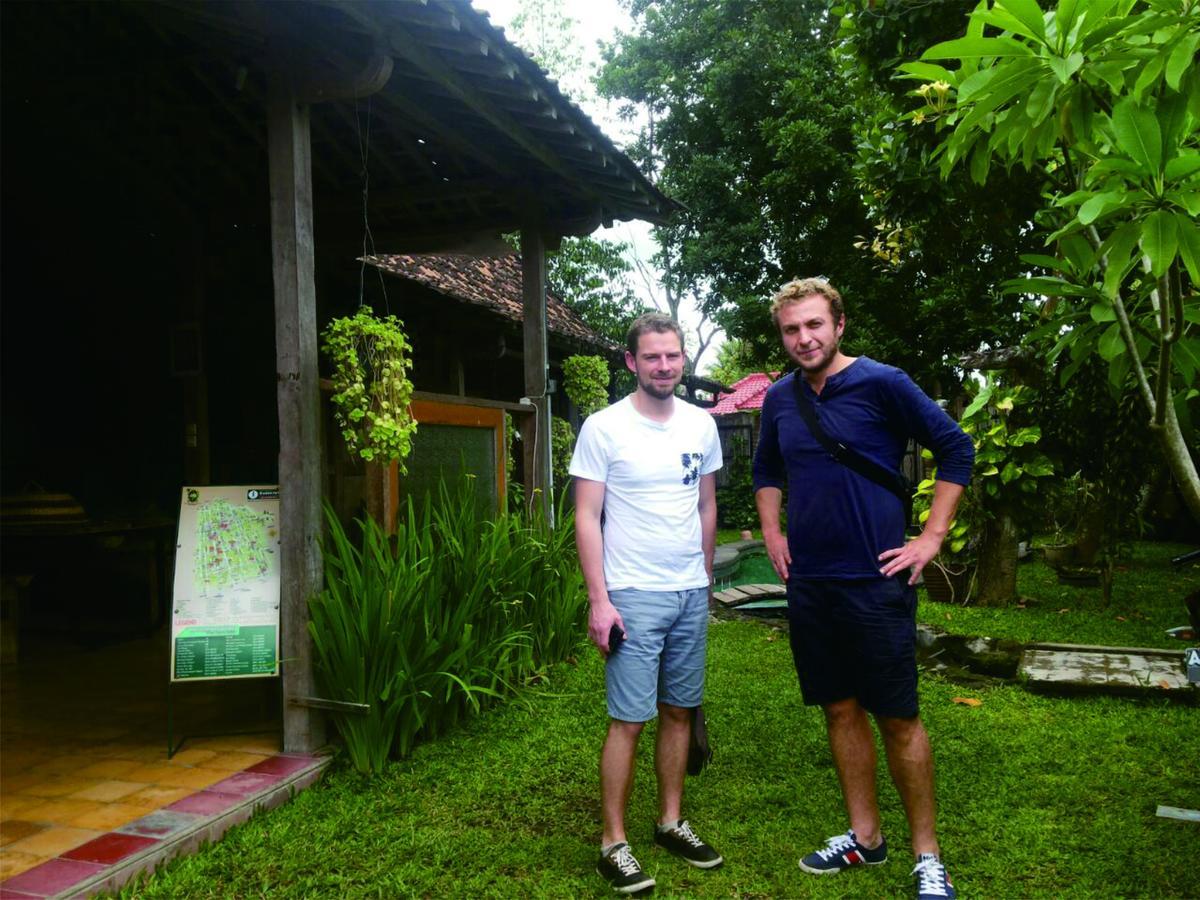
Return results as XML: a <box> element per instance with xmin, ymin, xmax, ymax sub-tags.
<box><xmin>364</xmin><ymin>253</ymin><xmax>617</xmax><ymax>352</ymax></box>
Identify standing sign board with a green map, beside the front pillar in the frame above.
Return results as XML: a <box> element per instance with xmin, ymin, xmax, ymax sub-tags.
<box><xmin>170</xmin><ymin>485</ymin><xmax>280</xmax><ymax>680</ymax></box>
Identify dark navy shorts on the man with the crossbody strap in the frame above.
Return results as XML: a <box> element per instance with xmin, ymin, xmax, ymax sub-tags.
<box><xmin>787</xmin><ymin>572</ymin><xmax>918</xmax><ymax>719</ymax></box>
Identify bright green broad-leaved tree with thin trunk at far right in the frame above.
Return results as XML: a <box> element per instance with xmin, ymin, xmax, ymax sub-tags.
<box><xmin>900</xmin><ymin>0</ymin><xmax>1200</xmax><ymax>520</ymax></box>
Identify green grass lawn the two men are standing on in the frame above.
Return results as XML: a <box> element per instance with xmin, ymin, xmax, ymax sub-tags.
<box><xmin>117</xmin><ymin>580</ymin><xmax>1200</xmax><ymax>898</ymax></box>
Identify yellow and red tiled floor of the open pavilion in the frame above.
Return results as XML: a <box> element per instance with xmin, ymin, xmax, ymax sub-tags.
<box><xmin>0</xmin><ymin>636</ymin><xmax>320</xmax><ymax>898</ymax></box>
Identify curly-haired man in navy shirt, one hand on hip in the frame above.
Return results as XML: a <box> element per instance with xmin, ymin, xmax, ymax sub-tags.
<box><xmin>754</xmin><ymin>278</ymin><xmax>974</xmax><ymax>898</ymax></box>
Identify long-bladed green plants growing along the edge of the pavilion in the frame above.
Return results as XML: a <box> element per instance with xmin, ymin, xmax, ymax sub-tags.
<box><xmin>308</xmin><ymin>475</ymin><xmax>587</xmax><ymax>774</ymax></box>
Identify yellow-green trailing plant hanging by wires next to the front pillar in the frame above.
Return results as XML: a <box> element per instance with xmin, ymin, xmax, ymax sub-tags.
<box><xmin>322</xmin><ymin>307</ymin><xmax>416</xmax><ymax>473</ymax></box>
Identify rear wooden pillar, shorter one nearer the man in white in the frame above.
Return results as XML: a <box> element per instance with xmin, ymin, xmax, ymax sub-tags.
<box><xmin>521</xmin><ymin>228</ymin><xmax>553</xmax><ymax>517</ymax></box>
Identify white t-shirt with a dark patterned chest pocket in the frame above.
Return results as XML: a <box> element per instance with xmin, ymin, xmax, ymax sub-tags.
<box><xmin>571</xmin><ymin>397</ymin><xmax>721</xmax><ymax>590</ymax></box>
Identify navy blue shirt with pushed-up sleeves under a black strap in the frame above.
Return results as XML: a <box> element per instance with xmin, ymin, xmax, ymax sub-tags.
<box><xmin>754</xmin><ymin>356</ymin><xmax>974</xmax><ymax>580</ymax></box>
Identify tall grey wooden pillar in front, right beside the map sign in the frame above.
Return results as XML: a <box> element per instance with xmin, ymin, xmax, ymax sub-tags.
<box><xmin>266</xmin><ymin>86</ymin><xmax>325</xmax><ymax>752</ymax></box>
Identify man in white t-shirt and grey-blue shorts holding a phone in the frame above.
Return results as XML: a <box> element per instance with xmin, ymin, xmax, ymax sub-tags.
<box><xmin>571</xmin><ymin>313</ymin><xmax>724</xmax><ymax>894</ymax></box>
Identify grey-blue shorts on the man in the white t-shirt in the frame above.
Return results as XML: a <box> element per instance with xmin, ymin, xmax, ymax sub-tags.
<box><xmin>605</xmin><ymin>587</ymin><xmax>708</xmax><ymax>722</ymax></box>
